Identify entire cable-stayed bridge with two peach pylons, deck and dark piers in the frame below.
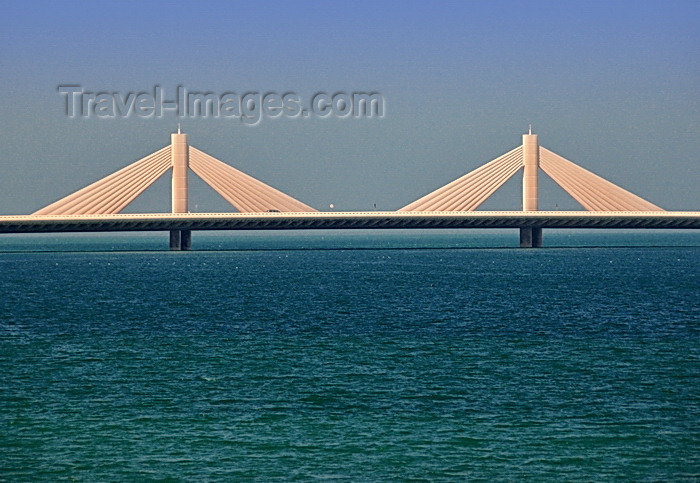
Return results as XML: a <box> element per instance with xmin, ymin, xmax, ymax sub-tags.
<box><xmin>0</xmin><ymin>129</ymin><xmax>700</xmax><ymax>250</ymax></box>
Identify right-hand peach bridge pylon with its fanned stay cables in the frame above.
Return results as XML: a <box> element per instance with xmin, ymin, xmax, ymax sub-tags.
<box><xmin>399</xmin><ymin>131</ymin><xmax>664</xmax><ymax>211</ymax></box>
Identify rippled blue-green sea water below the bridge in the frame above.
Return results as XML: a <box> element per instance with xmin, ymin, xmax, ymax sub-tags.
<box><xmin>0</xmin><ymin>232</ymin><xmax>700</xmax><ymax>481</ymax></box>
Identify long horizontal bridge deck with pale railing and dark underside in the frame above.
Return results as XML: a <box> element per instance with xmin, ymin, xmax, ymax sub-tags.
<box><xmin>0</xmin><ymin>211</ymin><xmax>700</xmax><ymax>233</ymax></box>
